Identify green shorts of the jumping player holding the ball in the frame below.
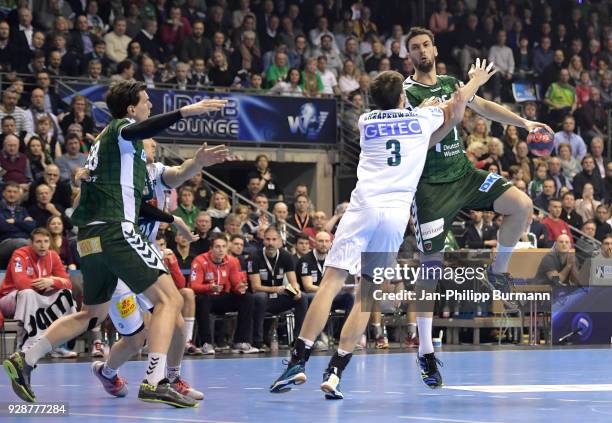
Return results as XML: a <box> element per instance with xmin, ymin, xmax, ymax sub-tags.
<box><xmin>412</xmin><ymin>168</ymin><xmax>512</xmax><ymax>254</ymax></box>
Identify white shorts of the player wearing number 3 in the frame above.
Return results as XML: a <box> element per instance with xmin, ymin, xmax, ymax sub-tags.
<box><xmin>325</xmin><ymin>207</ymin><xmax>410</xmax><ymax>275</ymax></box>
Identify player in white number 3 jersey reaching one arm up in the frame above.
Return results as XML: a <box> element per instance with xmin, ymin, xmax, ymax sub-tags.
<box><xmin>270</xmin><ymin>63</ymin><xmax>495</xmax><ymax>399</ymax></box>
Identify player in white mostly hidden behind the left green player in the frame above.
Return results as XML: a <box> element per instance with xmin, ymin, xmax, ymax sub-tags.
<box><xmin>91</xmin><ymin>139</ymin><xmax>225</xmax><ymax>400</ymax></box>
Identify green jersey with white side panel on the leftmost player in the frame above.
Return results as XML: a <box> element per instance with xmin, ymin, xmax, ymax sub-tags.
<box><xmin>72</xmin><ymin>119</ymin><xmax>147</xmax><ymax>226</ymax></box>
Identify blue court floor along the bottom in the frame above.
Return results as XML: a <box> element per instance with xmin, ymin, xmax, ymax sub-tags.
<box><xmin>0</xmin><ymin>349</ymin><xmax>612</xmax><ymax>423</ymax></box>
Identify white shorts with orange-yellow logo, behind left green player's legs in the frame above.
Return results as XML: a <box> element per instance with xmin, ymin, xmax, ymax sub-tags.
<box><xmin>108</xmin><ymin>279</ymin><xmax>153</xmax><ymax>336</ymax></box>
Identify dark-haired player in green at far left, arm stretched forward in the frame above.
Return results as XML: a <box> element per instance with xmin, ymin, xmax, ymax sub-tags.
<box><xmin>3</xmin><ymin>81</ymin><xmax>228</xmax><ymax>407</ymax></box>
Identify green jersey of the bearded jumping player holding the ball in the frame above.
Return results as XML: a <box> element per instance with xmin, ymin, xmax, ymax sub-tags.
<box><xmin>404</xmin><ymin>75</ymin><xmax>473</xmax><ymax>184</ymax></box>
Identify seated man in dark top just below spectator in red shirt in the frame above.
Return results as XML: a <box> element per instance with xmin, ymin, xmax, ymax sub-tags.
<box><xmin>535</xmin><ymin>234</ymin><xmax>579</xmax><ymax>286</ymax></box>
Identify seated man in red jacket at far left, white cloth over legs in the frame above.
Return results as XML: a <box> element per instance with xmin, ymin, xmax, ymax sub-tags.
<box><xmin>0</xmin><ymin>228</ymin><xmax>77</xmax><ymax>358</ymax></box>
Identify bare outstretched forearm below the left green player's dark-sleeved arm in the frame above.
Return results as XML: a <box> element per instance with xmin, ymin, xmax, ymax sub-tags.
<box><xmin>162</xmin><ymin>143</ymin><xmax>236</xmax><ymax>188</ymax></box>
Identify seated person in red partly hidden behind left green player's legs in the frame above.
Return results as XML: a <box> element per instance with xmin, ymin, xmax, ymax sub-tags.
<box><xmin>156</xmin><ymin>234</ymin><xmax>202</xmax><ymax>355</ymax></box>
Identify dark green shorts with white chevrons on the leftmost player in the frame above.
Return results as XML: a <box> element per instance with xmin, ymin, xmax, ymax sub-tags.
<box><xmin>77</xmin><ymin>222</ymin><xmax>168</xmax><ymax>305</ymax></box>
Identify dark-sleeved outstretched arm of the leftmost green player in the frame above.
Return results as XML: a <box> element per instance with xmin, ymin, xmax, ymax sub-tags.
<box><xmin>121</xmin><ymin>99</ymin><xmax>227</xmax><ymax>141</ymax></box>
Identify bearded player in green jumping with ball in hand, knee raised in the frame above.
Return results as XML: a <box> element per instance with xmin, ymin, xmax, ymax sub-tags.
<box><xmin>404</xmin><ymin>27</ymin><xmax>551</xmax><ymax>388</ymax></box>
